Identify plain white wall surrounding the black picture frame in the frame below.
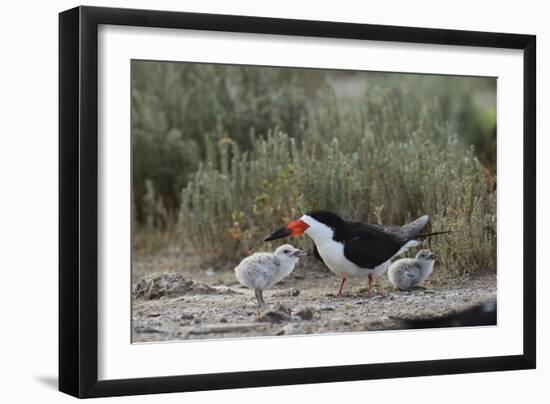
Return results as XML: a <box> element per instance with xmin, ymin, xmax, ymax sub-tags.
<box><xmin>0</xmin><ymin>0</ymin><xmax>550</xmax><ymax>404</ymax></box>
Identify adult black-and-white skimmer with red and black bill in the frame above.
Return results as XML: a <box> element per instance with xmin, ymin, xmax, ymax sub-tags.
<box><xmin>265</xmin><ymin>210</ymin><xmax>446</xmax><ymax>296</ymax></box>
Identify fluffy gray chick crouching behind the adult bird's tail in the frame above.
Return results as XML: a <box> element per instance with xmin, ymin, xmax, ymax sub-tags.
<box><xmin>388</xmin><ymin>250</ymin><xmax>435</xmax><ymax>289</ymax></box>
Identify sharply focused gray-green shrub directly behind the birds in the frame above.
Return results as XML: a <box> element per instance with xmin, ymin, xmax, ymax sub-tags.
<box><xmin>180</xmin><ymin>89</ymin><xmax>496</xmax><ymax>275</ymax></box>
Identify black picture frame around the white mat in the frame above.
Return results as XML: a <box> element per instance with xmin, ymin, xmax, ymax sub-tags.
<box><xmin>59</xmin><ymin>7</ymin><xmax>536</xmax><ymax>398</ymax></box>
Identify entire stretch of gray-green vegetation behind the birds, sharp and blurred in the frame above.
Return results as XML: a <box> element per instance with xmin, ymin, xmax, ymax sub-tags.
<box><xmin>132</xmin><ymin>61</ymin><xmax>496</xmax><ymax>277</ymax></box>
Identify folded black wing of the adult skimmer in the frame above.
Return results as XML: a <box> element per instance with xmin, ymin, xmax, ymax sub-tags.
<box><xmin>344</xmin><ymin>223</ymin><xmax>407</xmax><ymax>269</ymax></box>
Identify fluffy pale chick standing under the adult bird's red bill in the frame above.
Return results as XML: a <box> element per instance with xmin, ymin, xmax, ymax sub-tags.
<box><xmin>235</xmin><ymin>244</ymin><xmax>306</xmax><ymax>306</ymax></box>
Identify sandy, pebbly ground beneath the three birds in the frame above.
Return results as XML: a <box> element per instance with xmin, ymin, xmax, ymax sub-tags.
<box><xmin>132</xmin><ymin>254</ymin><xmax>496</xmax><ymax>342</ymax></box>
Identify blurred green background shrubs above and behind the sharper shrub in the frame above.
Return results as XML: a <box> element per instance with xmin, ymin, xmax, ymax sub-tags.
<box><xmin>132</xmin><ymin>61</ymin><xmax>496</xmax><ymax>229</ymax></box>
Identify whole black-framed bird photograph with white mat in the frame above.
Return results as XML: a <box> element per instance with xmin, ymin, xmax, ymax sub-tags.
<box><xmin>59</xmin><ymin>7</ymin><xmax>536</xmax><ymax>397</ymax></box>
